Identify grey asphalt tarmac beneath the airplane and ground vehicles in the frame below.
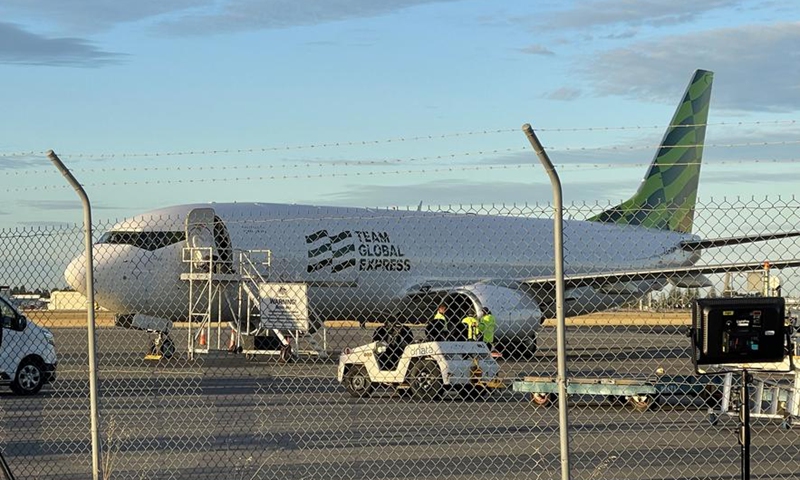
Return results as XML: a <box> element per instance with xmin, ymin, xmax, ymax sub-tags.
<box><xmin>0</xmin><ymin>312</ymin><xmax>800</xmax><ymax>480</ymax></box>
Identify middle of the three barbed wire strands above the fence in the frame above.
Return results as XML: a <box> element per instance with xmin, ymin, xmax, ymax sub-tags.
<box><xmin>6</xmin><ymin>140</ymin><xmax>800</xmax><ymax>176</ymax></box>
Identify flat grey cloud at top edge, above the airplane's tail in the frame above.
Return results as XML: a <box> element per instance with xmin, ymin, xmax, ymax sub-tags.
<box><xmin>539</xmin><ymin>0</ymin><xmax>741</xmax><ymax>30</ymax></box>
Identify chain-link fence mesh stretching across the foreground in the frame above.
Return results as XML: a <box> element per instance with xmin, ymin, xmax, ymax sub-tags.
<box><xmin>0</xmin><ymin>198</ymin><xmax>800</xmax><ymax>479</ymax></box>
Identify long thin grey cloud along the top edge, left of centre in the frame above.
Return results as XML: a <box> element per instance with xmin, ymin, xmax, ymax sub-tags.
<box><xmin>157</xmin><ymin>0</ymin><xmax>459</xmax><ymax>35</ymax></box>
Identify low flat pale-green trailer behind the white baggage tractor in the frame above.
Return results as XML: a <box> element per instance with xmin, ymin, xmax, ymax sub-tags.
<box><xmin>513</xmin><ymin>373</ymin><xmax>722</xmax><ymax>412</ymax></box>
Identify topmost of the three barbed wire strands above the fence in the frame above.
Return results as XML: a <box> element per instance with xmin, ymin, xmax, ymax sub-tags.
<box><xmin>0</xmin><ymin>120</ymin><xmax>797</xmax><ymax>159</ymax></box>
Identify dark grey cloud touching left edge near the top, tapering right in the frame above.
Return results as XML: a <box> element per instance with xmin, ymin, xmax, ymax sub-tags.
<box><xmin>0</xmin><ymin>22</ymin><xmax>120</xmax><ymax>67</ymax></box>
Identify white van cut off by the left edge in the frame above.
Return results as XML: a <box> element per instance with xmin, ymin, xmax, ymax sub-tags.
<box><xmin>0</xmin><ymin>296</ymin><xmax>57</xmax><ymax>395</ymax></box>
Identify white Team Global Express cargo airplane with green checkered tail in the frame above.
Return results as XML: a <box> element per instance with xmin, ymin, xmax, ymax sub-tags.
<box><xmin>65</xmin><ymin>70</ymin><xmax>800</xmax><ymax>356</ymax></box>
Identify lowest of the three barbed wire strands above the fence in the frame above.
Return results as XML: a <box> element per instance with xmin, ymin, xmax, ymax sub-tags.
<box><xmin>6</xmin><ymin>158</ymin><xmax>800</xmax><ymax>192</ymax></box>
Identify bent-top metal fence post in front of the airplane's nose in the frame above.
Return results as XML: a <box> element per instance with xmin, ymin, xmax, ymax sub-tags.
<box><xmin>47</xmin><ymin>150</ymin><xmax>100</xmax><ymax>480</ymax></box>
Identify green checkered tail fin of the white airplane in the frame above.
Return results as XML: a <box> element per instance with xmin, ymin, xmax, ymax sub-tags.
<box><xmin>589</xmin><ymin>70</ymin><xmax>714</xmax><ymax>233</ymax></box>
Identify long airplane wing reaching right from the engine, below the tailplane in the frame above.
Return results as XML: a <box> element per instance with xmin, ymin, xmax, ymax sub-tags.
<box><xmin>522</xmin><ymin>259</ymin><xmax>800</xmax><ymax>288</ymax></box>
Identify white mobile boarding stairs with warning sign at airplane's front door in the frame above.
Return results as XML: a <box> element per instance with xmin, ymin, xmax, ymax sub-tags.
<box><xmin>180</xmin><ymin>247</ymin><xmax>326</xmax><ymax>361</ymax></box>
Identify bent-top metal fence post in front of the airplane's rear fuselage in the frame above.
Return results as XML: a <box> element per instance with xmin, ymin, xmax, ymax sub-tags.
<box><xmin>522</xmin><ymin>123</ymin><xmax>571</xmax><ymax>480</ymax></box>
